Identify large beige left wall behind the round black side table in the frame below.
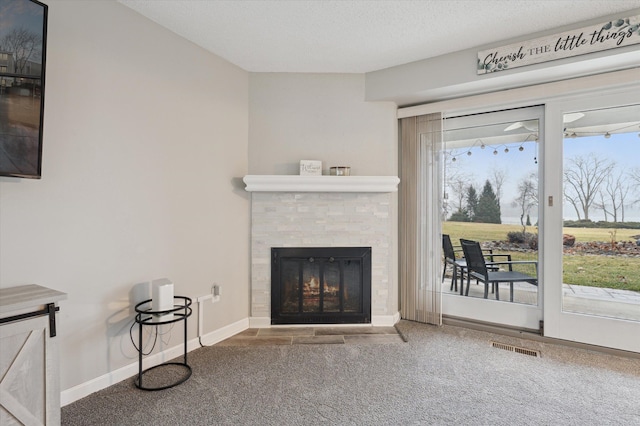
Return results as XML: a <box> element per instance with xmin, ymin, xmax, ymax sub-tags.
<box><xmin>0</xmin><ymin>0</ymin><xmax>249</xmax><ymax>390</ymax></box>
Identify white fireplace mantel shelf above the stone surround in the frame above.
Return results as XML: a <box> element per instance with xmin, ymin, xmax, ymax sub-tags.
<box><xmin>243</xmin><ymin>175</ymin><xmax>400</xmax><ymax>192</ymax></box>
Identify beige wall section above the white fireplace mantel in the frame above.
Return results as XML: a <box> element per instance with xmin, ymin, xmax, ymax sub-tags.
<box><xmin>249</xmin><ymin>73</ymin><xmax>398</xmax><ymax>176</ymax></box>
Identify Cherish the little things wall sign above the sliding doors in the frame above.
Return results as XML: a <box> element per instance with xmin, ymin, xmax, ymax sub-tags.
<box><xmin>478</xmin><ymin>15</ymin><xmax>640</xmax><ymax>74</ymax></box>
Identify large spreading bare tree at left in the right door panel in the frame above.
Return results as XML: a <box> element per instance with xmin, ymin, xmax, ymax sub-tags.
<box><xmin>564</xmin><ymin>153</ymin><xmax>615</xmax><ymax>220</ymax></box>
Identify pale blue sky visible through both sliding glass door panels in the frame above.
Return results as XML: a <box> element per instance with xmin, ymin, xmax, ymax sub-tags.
<box><xmin>446</xmin><ymin>129</ymin><xmax>640</xmax><ymax>223</ymax></box>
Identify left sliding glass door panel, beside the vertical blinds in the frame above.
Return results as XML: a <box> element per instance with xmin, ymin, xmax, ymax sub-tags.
<box><xmin>440</xmin><ymin>107</ymin><xmax>544</xmax><ymax>330</ymax></box>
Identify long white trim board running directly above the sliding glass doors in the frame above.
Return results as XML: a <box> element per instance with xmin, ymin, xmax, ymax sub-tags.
<box><xmin>397</xmin><ymin>68</ymin><xmax>640</xmax><ymax>118</ymax></box>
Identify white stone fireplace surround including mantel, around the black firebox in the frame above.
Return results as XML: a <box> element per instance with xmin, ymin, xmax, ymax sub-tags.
<box><xmin>244</xmin><ymin>175</ymin><xmax>399</xmax><ymax>328</ymax></box>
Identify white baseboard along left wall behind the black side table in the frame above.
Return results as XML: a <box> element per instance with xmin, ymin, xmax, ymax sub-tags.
<box><xmin>60</xmin><ymin>318</ymin><xmax>249</xmax><ymax>407</ymax></box>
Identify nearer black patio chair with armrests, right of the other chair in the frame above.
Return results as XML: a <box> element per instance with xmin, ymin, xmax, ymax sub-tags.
<box><xmin>460</xmin><ymin>239</ymin><xmax>538</xmax><ymax>302</ymax></box>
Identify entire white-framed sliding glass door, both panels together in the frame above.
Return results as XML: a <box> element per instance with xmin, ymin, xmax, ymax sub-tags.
<box><xmin>403</xmin><ymin>74</ymin><xmax>640</xmax><ymax>353</ymax></box>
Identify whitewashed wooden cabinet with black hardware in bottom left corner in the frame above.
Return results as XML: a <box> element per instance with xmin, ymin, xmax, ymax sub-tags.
<box><xmin>0</xmin><ymin>284</ymin><xmax>66</xmax><ymax>426</ymax></box>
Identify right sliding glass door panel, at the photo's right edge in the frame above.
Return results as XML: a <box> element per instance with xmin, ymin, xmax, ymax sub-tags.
<box><xmin>544</xmin><ymin>91</ymin><xmax>640</xmax><ymax>352</ymax></box>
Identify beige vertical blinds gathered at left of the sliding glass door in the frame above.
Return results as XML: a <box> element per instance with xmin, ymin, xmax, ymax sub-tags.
<box><xmin>398</xmin><ymin>113</ymin><xmax>442</xmax><ymax>325</ymax></box>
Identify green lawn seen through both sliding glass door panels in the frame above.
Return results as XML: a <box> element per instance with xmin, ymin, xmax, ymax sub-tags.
<box><xmin>442</xmin><ymin>222</ymin><xmax>640</xmax><ymax>292</ymax></box>
